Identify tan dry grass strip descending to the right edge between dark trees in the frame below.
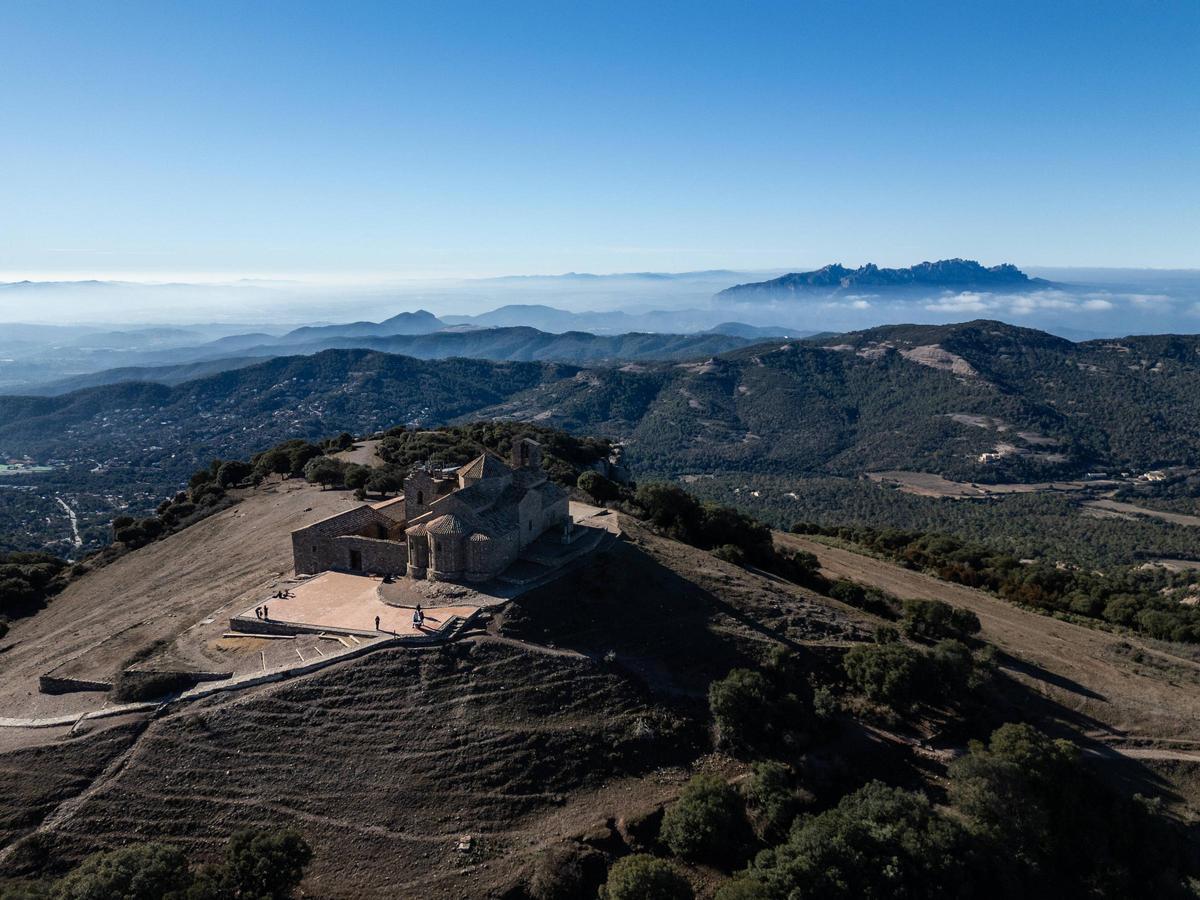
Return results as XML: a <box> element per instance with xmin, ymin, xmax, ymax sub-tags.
<box><xmin>776</xmin><ymin>534</ymin><xmax>1200</xmax><ymax>758</ymax></box>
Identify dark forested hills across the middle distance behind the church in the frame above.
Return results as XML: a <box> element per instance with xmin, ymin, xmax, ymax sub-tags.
<box><xmin>9</xmin><ymin>320</ymin><xmax>1200</xmax><ymax>480</ymax></box>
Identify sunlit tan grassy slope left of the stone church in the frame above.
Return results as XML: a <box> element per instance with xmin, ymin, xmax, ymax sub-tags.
<box><xmin>0</xmin><ymin>480</ymin><xmax>354</xmax><ymax>718</ymax></box>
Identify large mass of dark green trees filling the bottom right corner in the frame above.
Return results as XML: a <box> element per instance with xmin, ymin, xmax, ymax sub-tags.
<box><xmin>718</xmin><ymin>725</ymin><xmax>1195</xmax><ymax>900</ymax></box>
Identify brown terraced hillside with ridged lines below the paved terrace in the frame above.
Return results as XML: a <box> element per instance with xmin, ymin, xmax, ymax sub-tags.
<box><xmin>18</xmin><ymin>640</ymin><xmax>688</xmax><ymax>898</ymax></box>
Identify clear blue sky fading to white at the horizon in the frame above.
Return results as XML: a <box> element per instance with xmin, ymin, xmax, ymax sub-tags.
<box><xmin>0</xmin><ymin>0</ymin><xmax>1200</xmax><ymax>280</ymax></box>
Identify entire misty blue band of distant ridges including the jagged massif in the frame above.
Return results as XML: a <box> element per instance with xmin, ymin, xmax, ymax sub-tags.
<box><xmin>0</xmin><ymin>259</ymin><xmax>1200</xmax><ymax>394</ymax></box>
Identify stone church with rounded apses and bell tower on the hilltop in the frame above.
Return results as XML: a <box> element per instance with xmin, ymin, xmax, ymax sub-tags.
<box><xmin>292</xmin><ymin>438</ymin><xmax>571</xmax><ymax>581</ymax></box>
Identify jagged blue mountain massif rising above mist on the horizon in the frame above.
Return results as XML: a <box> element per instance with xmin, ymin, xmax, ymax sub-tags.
<box><xmin>718</xmin><ymin>259</ymin><xmax>1051</xmax><ymax>300</ymax></box>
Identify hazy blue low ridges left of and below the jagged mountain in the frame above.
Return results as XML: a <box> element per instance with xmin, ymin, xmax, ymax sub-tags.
<box><xmin>0</xmin><ymin>305</ymin><xmax>811</xmax><ymax>395</ymax></box>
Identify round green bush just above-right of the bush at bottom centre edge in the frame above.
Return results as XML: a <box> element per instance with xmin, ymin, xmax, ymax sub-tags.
<box><xmin>659</xmin><ymin>775</ymin><xmax>745</xmax><ymax>862</ymax></box>
